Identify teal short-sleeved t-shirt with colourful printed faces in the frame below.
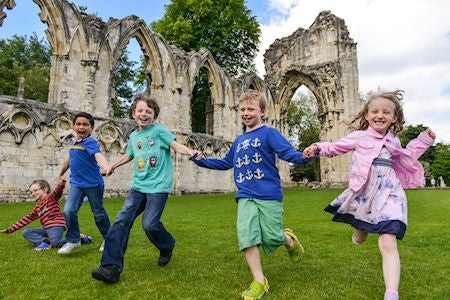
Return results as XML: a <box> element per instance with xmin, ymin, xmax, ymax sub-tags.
<box><xmin>127</xmin><ymin>124</ymin><xmax>175</xmax><ymax>193</ymax></box>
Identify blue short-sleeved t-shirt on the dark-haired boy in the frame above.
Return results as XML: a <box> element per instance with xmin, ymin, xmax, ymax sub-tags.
<box><xmin>69</xmin><ymin>136</ymin><xmax>104</xmax><ymax>188</ymax></box>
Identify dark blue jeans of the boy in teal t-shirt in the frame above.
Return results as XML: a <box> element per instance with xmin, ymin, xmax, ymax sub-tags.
<box><xmin>101</xmin><ymin>189</ymin><xmax>175</xmax><ymax>272</ymax></box>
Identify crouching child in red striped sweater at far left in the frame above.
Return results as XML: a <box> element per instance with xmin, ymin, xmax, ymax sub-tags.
<box><xmin>0</xmin><ymin>179</ymin><xmax>92</xmax><ymax>251</ymax></box>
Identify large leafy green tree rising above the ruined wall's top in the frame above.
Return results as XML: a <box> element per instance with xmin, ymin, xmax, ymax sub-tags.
<box><xmin>150</xmin><ymin>0</ymin><xmax>261</xmax><ymax>76</ymax></box>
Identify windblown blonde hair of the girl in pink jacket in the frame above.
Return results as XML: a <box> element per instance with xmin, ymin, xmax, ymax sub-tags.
<box><xmin>350</xmin><ymin>90</ymin><xmax>405</xmax><ymax>135</ymax></box>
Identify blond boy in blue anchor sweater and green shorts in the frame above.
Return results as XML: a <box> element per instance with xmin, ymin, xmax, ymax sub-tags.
<box><xmin>192</xmin><ymin>90</ymin><xmax>311</xmax><ymax>299</ymax></box>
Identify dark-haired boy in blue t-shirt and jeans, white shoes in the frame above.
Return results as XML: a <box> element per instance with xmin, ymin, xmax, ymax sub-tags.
<box><xmin>58</xmin><ymin>112</ymin><xmax>111</xmax><ymax>254</ymax></box>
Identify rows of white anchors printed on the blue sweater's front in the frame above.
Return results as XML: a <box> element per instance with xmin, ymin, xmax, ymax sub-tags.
<box><xmin>235</xmin><ymin>137</ymin><xmax>264</xmax><ymax>183</ymax></box>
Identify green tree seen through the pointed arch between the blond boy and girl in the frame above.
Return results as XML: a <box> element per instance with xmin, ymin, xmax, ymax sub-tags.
<box><xmin>288</xmin><ymin>91</ymin><xmax>320</xmax><ymax>181</ymax></box>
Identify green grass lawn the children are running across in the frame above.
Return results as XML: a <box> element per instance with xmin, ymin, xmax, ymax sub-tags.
<box><xmin>0</xmin><ymin>189</ymin><xmax>450</xmax><ymax>299</ymax></box>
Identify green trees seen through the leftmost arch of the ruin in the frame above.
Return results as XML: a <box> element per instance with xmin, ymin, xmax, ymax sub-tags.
<box><xmin>0</xmin><ymin>33</ymin><xmax>51</xmax><ymax>102</ymax></box>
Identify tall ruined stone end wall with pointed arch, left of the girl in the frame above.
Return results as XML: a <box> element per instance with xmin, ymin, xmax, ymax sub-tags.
<box><xmin>264</xmin><ymin>11</ymin><xmax>361</xmax><ymax>186</ymax></box>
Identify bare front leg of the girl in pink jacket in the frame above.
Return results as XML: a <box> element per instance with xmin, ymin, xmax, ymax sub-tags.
<box><xmin>378</xmin><ymin>233</ymin><xmax>400</xmax><ymax>291</ymax></box>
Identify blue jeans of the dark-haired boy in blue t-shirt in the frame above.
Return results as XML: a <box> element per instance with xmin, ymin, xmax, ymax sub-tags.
<box><xmin>64</xmin><ymin>185</ymin><xmax>111</xmax><ymax>243</ymax></box>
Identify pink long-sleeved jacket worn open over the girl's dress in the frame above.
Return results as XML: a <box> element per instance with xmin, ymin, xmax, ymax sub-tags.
<box><xmin>315</xmin><ymin>127</ymin><xmax>434</xmax><ymax>192</ymax></box>
